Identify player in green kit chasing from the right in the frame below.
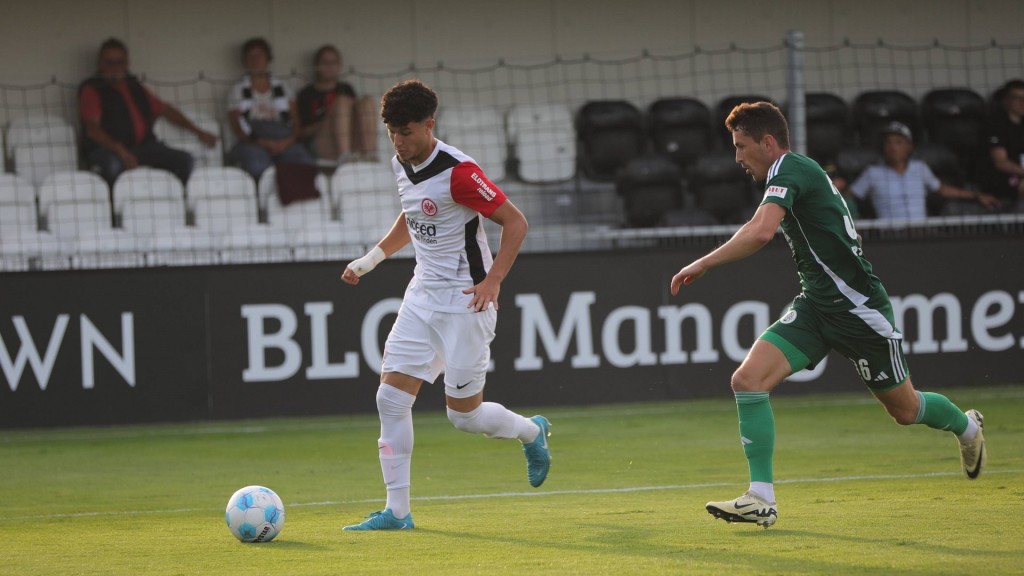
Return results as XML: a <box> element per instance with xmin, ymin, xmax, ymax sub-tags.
<box><xmin>671</xmin><ymin>102</ymin><xmax>986</xmax><ymax>528</ymax></box>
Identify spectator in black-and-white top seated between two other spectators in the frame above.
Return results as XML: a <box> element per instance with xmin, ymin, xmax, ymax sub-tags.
<box><xmin>227</xmin><ymin>38</ymin><xmax>315</xmax><ymax>180</ymax></box>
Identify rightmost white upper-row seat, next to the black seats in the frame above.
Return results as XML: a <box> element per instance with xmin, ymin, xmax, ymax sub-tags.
<box><xmin>508</xmin><ymin>105</ymin><xmax>577</xmax><ymax>183</ymax></box>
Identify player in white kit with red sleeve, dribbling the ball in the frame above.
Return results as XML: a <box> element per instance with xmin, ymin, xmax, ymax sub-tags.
<box><xmin>341</xmin><ymin>80</ymin><xmax>551</xmax><ymax>530</ymax></box>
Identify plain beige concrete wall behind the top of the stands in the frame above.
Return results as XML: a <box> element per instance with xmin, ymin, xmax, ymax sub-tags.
<box><xmin>0</xmin><ymin>0</ymin><xmax>1024</xmax><ymax>84</ymax></box>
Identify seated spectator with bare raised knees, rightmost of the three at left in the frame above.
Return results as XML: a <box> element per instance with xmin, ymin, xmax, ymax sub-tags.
<box><xmin>298</xmin><ymin>44</ymin><xmax>377</xmax><ymax>164</ymax></box>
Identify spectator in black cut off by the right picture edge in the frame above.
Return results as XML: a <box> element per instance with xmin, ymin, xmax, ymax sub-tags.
<box><xmin>989</xmin><ymin>80</ymin><xmax>1024</xmax><ymax>209</ymax></box>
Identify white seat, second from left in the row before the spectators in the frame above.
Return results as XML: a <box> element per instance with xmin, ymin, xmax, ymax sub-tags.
<box><xmin>39</xmin><ymin>170</ymin><xmax>112</xmax><ymax>241</ymax></box>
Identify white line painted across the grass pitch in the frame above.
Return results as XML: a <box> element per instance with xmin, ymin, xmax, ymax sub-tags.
<box><xmin>0</xmin><ymin>468</ymin><xmax>1024</xmax><ymax>523</ymax></box>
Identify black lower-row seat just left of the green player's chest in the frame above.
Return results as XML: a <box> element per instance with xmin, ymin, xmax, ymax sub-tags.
<box><xmin>690</xmin><ymin>152</ymin><xmax>756</xmax><ymax>223</ymax></box>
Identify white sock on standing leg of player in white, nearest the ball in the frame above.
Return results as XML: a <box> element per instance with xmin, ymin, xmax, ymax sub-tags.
<box><xmin>377</xmin><ymin>383</ymin><xmax>416</xmax><ymax>519</ymax></box>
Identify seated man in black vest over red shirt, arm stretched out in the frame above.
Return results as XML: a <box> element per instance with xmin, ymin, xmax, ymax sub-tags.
<box><xmin>78</xmin><ymin>38</ymin><xmax>217</xmax><ymax>184</ymax></box>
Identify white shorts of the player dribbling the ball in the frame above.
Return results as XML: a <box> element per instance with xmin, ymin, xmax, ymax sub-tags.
<box><xmin>381</xmin><ymin>301</ymin><xmax>498</xmax><ymax>398</ymax></box>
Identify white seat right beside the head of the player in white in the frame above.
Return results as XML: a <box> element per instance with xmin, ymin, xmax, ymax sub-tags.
<box><xmin>437</xmin><ymin>105</ymin><xmax>508</xmax><ymax>181</ymax></box>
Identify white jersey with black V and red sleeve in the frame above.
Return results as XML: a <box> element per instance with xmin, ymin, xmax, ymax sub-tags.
<box><xmin>391</xmin><ymin>140</ymin><xmax>507</xmax><ymax>313</ymax></box>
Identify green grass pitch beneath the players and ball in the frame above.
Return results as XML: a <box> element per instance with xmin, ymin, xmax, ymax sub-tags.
<box><xmin>0</xmin><ymin>386</ymin><xmax>1024</xmax><ymax>576</ymax></box>
